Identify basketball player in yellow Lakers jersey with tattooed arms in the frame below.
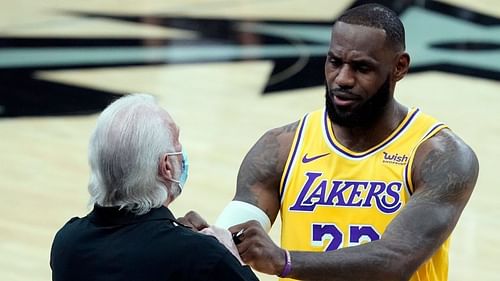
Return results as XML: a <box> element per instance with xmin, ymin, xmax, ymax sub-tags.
<box><xmin>216</xmin><ymin>4</ymin><xmax>479</xmax><ymax>281</ymax></box>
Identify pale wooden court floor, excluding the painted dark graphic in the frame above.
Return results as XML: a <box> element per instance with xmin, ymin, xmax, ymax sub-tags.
<box><xmin>0</xmin><ymin>0</ymin><xmax>500</xmax><ymax>281</ymax></box>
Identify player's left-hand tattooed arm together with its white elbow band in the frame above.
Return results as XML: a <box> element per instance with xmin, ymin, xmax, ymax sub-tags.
<box><xmin>216</xmin><ymin>122</ymin><xmax>299</xmax><ymax>230</ymax></box>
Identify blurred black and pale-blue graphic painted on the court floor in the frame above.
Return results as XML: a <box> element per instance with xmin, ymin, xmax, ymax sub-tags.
<box><xmin>0</xmin><ymin>0</ymin><xmax>500</xmax><ymax>117</ymax></box>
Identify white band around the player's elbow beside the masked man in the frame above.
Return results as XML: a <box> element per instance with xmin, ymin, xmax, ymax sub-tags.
<box><xmin>215</xmin><ymin>201</ymin><xmax>271</xmax><ymax>232</ymax></box>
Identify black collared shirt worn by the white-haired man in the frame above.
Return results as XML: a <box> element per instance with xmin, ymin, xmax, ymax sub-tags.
<box><xmin>50</xmin><ymin>203</ymin><xmax>257</xmax><ymax>281</ymax></box>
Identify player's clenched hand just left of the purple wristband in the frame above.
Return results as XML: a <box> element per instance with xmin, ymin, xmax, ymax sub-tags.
<box><xmin>229</xmin><ymin>220</ymin><xmax>285</xmax><ymax>275</ymax></box>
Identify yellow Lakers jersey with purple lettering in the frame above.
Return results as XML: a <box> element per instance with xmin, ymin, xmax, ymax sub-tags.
<box><xmin>280</xmin><ymin>108</ymin><xmax>449</xmax><ymax>281</ymax></box>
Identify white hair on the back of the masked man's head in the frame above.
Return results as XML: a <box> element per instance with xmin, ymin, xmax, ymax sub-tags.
<box><xmin>88</xmin><ymin>94</ymin><xmax>173</xmax><ymax>215</ymax></box>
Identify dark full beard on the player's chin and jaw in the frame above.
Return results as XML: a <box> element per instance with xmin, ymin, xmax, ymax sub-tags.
<box><xmin>325</xmin><ymin>76</ymin><xmax>391</xmax><ymax>128</ymax></box>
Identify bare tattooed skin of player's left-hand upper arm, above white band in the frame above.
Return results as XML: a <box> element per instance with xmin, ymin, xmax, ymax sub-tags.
<box><xmin>234</xmin><ymin>122</ymin><xmax>299</xmax><ymax>222</ymax></box>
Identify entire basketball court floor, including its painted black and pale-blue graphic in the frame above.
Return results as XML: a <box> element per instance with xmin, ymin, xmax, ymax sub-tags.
<box><xmin>0</xmin><ymin>0</ymin><xmax>500</xmax><ymax>281</ymax></box>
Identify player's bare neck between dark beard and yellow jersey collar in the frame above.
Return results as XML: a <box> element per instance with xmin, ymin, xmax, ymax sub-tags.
<box><xmin>332</xmin><ymin>101</ymin><xmax>408</xmax><ymax>152</ymax></box>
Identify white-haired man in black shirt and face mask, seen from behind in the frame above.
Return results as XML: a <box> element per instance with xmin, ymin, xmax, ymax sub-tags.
<box><xmin>50</xmin><ymin>94</ymin><xmax>257</xmax><ymax>281</ymax></box>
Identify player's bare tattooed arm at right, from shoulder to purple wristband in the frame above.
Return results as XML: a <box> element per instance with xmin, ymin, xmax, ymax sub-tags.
<box><xmin>290</xmin><ymin>130</ymin><xmax>479</xmax><ymax>281</ymax></box>
